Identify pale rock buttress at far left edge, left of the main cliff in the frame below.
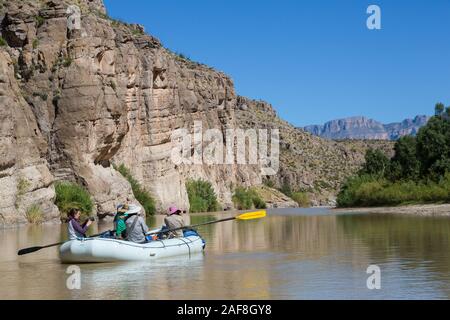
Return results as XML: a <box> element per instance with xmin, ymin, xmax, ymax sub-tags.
<box><xmin>0</xmin><ymin>51</ymin><xmax>59</xmax><ymax>225</ymax></box>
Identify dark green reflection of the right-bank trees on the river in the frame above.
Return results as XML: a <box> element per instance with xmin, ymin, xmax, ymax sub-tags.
<box><xmin>337</xmin><ymin>214</ymin><xmax>450</xmax><ymax>299</ymax></box>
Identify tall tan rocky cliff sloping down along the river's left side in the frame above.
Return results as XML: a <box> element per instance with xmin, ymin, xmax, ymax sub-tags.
<box><xmin>0</xmin><ymin>0</ymin><xmax>394</xmax><ymax>224</ymax></box>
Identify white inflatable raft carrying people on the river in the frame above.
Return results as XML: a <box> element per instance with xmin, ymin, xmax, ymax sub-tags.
<box><xmin>59</xmin><ymin>236</ymin><xmax>204</xmax><ymax>263</ymax></box>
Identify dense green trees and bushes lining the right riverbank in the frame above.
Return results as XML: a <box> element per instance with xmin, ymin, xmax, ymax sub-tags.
<box><xmin>337</xmin><ymin>103</ymin><xmax>450</xmax><ymax>207</ymax></box>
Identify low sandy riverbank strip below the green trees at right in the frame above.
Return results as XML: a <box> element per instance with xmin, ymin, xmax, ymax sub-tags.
<box><xmin>331</xmin><ymin>204</ymin><xmax>450</xmax><ymax>216</ymax></box>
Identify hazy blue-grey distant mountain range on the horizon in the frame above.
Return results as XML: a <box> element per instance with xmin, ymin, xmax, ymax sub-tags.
<box><xmin>303</xmin><ymin>115</ymin><xmax>430</xmax><ymax>140</ymax></box>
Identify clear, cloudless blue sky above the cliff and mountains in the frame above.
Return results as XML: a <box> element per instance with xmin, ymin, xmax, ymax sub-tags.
<box><xmin>105</xmin><ymin>0</ymin><xmax>450</xmax><ymax>126</ymax></box>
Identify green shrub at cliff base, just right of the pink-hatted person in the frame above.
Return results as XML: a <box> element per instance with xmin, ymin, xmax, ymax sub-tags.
<box><xmin>186</xmin><ymin>180</ymin><xmax>220</xmax><ymax>213</ymax></box>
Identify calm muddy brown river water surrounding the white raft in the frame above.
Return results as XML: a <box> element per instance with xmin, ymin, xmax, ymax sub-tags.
<box><xmin>0</xmin><ymin>209</ymin><xmax>450</xmax><ymax>300</ymax></box>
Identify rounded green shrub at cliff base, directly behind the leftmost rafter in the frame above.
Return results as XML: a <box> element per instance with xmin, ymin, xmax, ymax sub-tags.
<box><xmin>55</xmin><ymin>182</ymin><xmax>94</xmax><ymax>216</ymax></box>
